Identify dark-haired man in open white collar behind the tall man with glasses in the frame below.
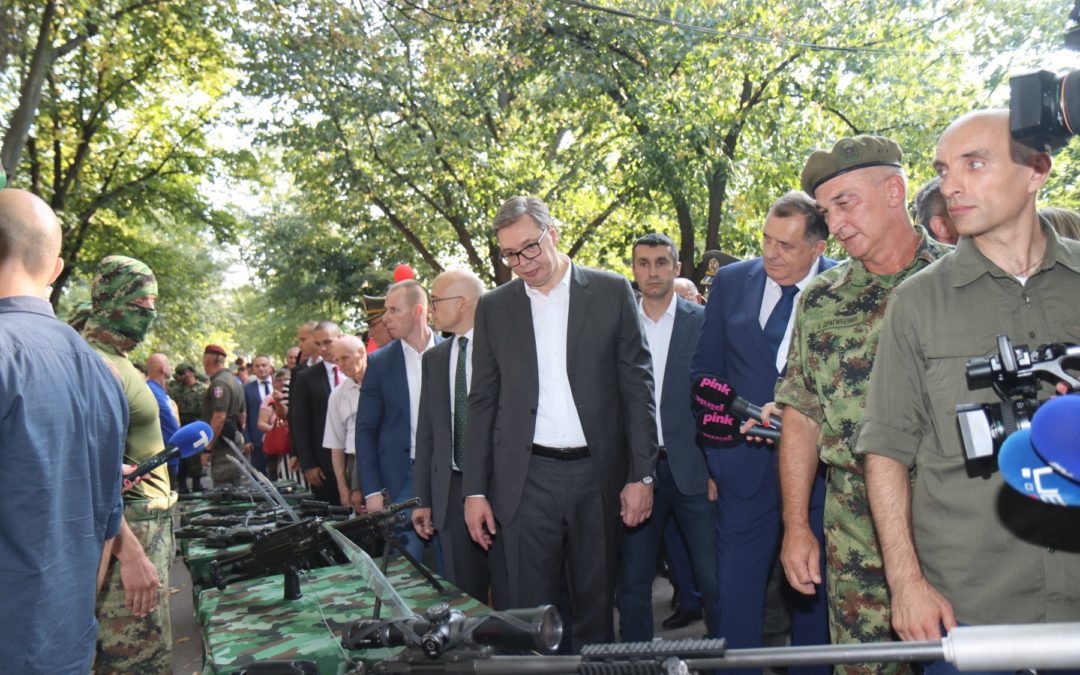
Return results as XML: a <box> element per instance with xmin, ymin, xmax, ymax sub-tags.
<box><xmin>617</xmin><ymin>233</ymin><xmax>717</xmax><ymax>642</ymax></box>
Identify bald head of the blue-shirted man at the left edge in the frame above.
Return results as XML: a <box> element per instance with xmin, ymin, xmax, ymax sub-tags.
<box><xmin>0</xmin><ymin>189</ymin><xmax>63</xmax><ymax>295</ymax></box>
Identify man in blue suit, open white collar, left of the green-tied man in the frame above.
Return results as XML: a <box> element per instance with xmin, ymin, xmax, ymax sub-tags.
<box><xmin>356</xmin><ymin>279</ymin><xmax>442</xmax><ymax>568</ymax></box>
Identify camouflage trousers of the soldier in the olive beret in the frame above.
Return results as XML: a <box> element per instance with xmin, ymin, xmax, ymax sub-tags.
<box><xmin>824</xmin><ymin>467</ymin><xmax>914</xmax><ymax>675</ymax></box>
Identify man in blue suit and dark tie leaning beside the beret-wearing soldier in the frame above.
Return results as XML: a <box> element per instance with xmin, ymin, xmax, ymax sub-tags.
<box><xmin>691</xmin><ymin>186</ymin><xmax>835</xmax><ymax>674</ymax></box>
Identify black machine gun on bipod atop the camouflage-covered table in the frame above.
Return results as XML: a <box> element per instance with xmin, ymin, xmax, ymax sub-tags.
<box><xmin>207</xmin><ymin>497</ymin><xmax>430</xmax><ymax>600</ymax></box>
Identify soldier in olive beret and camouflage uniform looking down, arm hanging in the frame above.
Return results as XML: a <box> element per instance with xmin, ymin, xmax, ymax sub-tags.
<box><xmin>775</xmin><ymin>136</ymin><xmax>948</xmax><ymax>675</ymax></box>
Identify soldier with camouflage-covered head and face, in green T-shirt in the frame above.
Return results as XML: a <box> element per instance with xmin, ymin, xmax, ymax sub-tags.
<box><xmin>83</xmin><ymin>256</ymin><xmax>176</xmax><ymax>674</ymax></box>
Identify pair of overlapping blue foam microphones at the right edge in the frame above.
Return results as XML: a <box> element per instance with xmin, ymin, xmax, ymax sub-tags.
<box><xmin>998</xmin><ymin>394</ymin><xmax>1080</xmax><ymax>507</ymax></box>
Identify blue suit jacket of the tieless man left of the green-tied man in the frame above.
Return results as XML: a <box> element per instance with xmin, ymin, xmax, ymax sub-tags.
<box><xmin>356</xmin><ymin>335</ymin><xmax>442</xmax><ymax>497</ymax></box>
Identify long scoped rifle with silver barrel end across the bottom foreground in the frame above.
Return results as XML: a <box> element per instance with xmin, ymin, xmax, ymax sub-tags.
<box><xmin>341</xmin><ymin>604</ymin><xmax>1080</xmax><ymax>675</ymax></box>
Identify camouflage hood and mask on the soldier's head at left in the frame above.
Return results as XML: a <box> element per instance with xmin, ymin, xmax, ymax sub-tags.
<box><xmin>83</xmin><ymin>256</ymin><xmax>158</xmax><ymax>353</ymax></box>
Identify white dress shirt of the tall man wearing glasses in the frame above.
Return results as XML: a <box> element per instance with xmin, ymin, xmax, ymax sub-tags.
<box><xmin>525</xmin><ymin>265</ymin><xmax>588</xmax><ymax>448</ymax></box>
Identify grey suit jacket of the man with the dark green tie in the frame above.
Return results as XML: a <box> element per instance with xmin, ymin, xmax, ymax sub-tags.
<box><xmin>413</xmin><ymin>336</ymin><xmax>457</xmax><ymax>529</ymax></box>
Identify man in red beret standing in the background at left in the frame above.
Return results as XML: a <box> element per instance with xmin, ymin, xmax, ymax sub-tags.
<box><xmin>202</xmin><ymin>345</ymin><xmax>245</xmax><ymax>485</ymax></box>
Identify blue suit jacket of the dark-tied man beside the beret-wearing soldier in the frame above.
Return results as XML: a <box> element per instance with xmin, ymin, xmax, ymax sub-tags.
<box><xmin>690</xmin><ymin>256</ymin><xmax>836</xmax><ymax>498</ymax></box>
